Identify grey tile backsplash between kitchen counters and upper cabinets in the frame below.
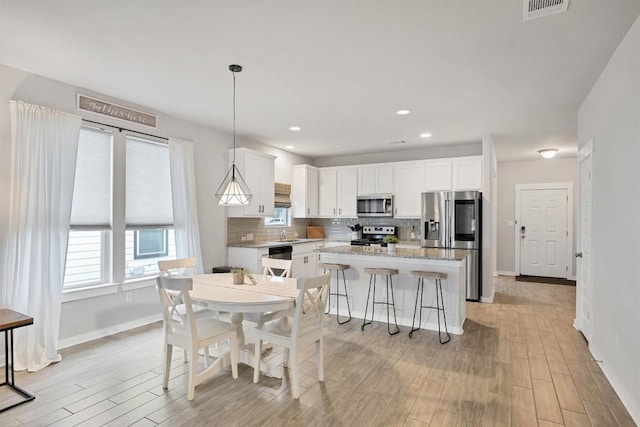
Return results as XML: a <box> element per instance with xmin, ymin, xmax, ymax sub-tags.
<box><xmin>227</xmin><ymin>218</ymin><xmax>420</xmax><ymax>244</ymax></box>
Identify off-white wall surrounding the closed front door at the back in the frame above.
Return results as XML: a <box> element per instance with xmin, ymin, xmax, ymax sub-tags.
<box><xmin>496</xmin><ymin>158</ymin><xmax>578</xmax><ymax>274</ymax></box>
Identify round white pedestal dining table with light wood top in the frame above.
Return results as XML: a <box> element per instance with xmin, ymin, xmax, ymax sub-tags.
<box><xmin>190</xmin><ymin>273</ymin><xmax>298</xmax><ymax>378</ymax></box>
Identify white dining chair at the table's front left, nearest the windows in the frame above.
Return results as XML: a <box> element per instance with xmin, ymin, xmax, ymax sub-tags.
<box><xmin>157</xmin><ymin>276</ymin><xmax>238</xmax><ymax>400</ymax></box>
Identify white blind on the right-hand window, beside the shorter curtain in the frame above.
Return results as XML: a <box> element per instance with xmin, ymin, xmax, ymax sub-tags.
<box><xmin>126</xmin><ymin>137</ymin><xmax>173</xmax><ymax>229</ymax></box>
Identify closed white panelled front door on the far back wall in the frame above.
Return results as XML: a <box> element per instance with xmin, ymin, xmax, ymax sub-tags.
<box><xmin>519</xmin><ymin>189</ymin><xmax>568</xmax><ymax>278</ymax></box>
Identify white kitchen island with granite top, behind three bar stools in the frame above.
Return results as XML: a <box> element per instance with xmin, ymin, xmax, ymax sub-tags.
<box><xmin>317</xmin><ymin>245</ymin><xmax>467</xmax><ymax>338</ymax></box>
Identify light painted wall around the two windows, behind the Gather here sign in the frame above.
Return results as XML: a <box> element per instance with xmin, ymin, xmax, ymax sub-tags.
<box><xmin>0</xmin><ymin>64</ymin><xmax>310</xmax><ymax>345</ymax></box>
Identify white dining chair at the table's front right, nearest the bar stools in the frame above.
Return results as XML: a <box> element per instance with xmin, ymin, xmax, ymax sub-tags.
<box><xmin>253</xmin><ymin>274</ymin><xmax>331</xmax><ymax>399</ymax></box>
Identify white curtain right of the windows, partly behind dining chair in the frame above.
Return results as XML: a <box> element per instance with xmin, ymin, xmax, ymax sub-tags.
<box><xmin>169</xmin><ymin>138</ymin><xmax>203</xmax><ymax>273</ymax></box>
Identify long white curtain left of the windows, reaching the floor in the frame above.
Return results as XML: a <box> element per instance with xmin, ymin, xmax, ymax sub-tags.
<box><xmin>2</xmin><ymin>101</ymin><xmax>82</xmax><ymax>371</ymax></box>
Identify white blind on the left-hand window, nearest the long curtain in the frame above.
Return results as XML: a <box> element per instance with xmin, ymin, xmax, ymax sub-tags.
<box><xmin>71</xmin><ymin>127</ymin><xmax>112</xmax><ymax>229</ymax></box>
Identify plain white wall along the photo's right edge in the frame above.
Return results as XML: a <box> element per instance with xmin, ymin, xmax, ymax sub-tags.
<box><xmin>578</xmin><ymin>14</ymin><xmax>640</xmax><ymax>424</ymax></box>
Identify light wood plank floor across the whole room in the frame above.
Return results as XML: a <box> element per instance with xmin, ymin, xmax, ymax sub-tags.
<box><xmin>0</xmin><ymin>278</ymin><xmax>635</xmax><ymax>427</ymax></box>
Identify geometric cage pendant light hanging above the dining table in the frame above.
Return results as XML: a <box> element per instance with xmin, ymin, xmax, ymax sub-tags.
<box><xmin>216</xmin><ymin>64</ymin><xmax>253</xmax><ymax>206</ymax></box>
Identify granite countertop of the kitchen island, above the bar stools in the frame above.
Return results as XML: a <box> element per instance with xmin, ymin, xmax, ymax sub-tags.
<box><xmin>316</xmin><ymin>245</ymin><xmax>468</xmax><ymax>261</ymax></box>
